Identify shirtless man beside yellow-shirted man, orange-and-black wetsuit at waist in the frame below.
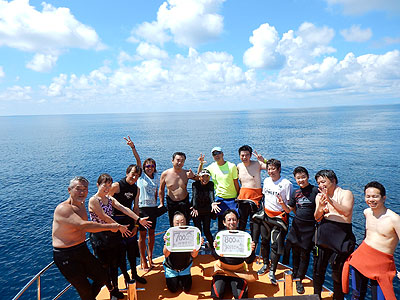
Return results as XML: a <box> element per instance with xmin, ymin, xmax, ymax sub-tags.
<box><xmin>237</xmin><ymin>145</ymin><xmax>267</xmax><ymax>232</ymax></box>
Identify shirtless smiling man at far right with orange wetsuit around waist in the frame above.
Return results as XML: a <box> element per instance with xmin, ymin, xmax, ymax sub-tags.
<box><xmin>342</xmin><ymin>181</ymin><xmax>400</xmax><ymax>300</ymax></box>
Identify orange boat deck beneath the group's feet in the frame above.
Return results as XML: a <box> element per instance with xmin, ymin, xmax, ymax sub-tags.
<box><xmin>97</xmin><ymin>254</ymin><xmax>333</xmax><ymax>300</ymax></box>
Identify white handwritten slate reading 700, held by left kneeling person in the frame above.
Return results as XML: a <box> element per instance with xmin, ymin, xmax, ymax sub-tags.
<box><xmin>165</xmin><ymin>226</ymin><xmax>201</xmax><ymax>252</ymax></box>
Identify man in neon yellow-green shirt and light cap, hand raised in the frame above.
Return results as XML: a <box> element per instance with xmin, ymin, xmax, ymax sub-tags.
<box><xmin>198</xmin><ymin>147</ymin><xmax>240</xmax><ymax>230</ymax></box>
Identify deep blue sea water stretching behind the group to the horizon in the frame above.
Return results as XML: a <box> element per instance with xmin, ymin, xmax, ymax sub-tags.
<box><xmin>0</xmin><ymin>105</ymin><xmax>400</xmax><ymax>299</ymax></box>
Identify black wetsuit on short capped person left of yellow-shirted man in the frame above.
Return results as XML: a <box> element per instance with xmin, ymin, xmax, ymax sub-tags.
<box><xmin>192</xmin><ymin>181</ymin><xmax>214</xmax><ymax>247</ymax></box>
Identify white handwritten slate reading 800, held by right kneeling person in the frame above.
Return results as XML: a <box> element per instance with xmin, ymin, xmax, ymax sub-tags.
<box><xmin>215</xmin><ymin>230</ymin><xmax>251</xmax><ymax>257</ymax></box>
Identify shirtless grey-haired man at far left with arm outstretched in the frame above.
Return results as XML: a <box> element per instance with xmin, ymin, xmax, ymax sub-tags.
<box><xmin>52</xmin><ymin>177</ymin><xmax>123</xmax><ymax>300</ymax></box>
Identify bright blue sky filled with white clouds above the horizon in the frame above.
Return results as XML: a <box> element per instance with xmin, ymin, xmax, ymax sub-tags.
<box><xmin>0</xmin><ymin>0</ymin><xmax>400</xmax><ymax>116</ymax></box>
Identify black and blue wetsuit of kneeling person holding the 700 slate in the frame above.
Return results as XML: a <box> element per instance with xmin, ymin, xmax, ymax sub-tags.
<box><xmin>163</xmin><ymin>252</ymin><xmax>193</xmax><ymax>293</ymax></box>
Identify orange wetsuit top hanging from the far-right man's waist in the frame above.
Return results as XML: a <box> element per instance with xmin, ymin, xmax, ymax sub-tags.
<box><xmin>342</xmin><ymin>242</ymin><xmax>396</xmax><ymax>300</ymax></box>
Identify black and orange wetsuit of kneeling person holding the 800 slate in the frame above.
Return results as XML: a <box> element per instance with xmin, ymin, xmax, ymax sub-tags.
<box><xmin>211</xmin><ymin>236</ymin><xmax>255</xmax><ymax>299</ymax></box>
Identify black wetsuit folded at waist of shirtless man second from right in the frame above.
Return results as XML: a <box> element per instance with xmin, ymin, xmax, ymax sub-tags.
<box><xmin>313</xmin><ymin>218</ymin><xmax>356</xmax><ymax>299</ymax></box>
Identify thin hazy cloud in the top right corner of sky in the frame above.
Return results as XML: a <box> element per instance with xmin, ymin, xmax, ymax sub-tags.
<box><xmin>325</xmin><ymin>0</ymin><xmax>400</xmax><ymax>15</ymax></box>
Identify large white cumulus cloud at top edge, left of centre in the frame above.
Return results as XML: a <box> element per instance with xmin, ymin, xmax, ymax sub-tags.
<box><xmin>129</xmin><ymin>0</ymin><xmax>225</xmax><ymax>47</ymax></box>
